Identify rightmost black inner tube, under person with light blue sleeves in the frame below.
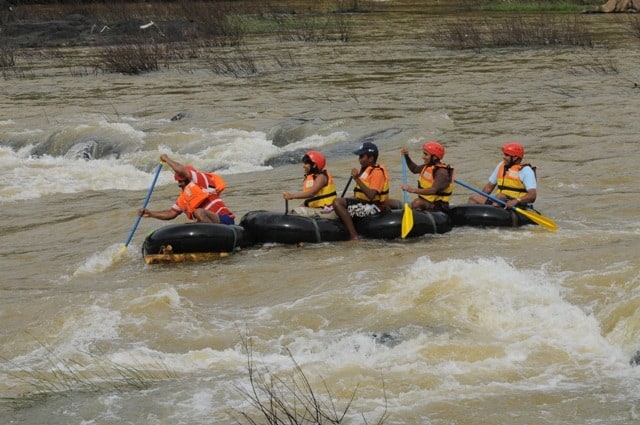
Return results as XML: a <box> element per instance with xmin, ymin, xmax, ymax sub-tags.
<box><xmin>449</xmin><ymin>204</ymin><xmax>536</xmax><ymax>227</ymax></box>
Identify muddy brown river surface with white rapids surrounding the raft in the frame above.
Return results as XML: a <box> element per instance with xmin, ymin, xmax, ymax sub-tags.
<box><xmin>0</xmin><ymin>0</ymin><xmax>640</xmax><ymax>425</ymax></box>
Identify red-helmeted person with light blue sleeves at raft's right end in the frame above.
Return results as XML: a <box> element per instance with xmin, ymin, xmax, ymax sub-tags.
<box><xmin>468</xmin><ymin>142</ymin><xmax>537</xmax><ymax>209</ymax></box>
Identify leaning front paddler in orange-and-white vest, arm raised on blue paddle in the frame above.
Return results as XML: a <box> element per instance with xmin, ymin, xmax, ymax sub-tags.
<box><xmin>138</xmin><ymin>154</ymin><xmax>235</xmax><ymax>224</ymax></box>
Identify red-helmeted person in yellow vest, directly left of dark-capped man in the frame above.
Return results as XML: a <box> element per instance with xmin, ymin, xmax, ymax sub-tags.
<box><xmin>282</xmin><ymin>151</ymin><xmax>337</xmax><ymax>218</ymax></box>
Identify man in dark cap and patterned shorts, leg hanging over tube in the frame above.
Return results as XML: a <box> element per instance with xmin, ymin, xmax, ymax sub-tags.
<box><xmin>333</xmin><ymin>142</ymin><xmax>389</xmax><ymax>240</ymax></box>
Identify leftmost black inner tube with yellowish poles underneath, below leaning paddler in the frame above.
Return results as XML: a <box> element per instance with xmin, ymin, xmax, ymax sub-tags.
<box><xmin>142</xmin><ymin>223</ymin><xmax>250</xmax><ymax>264</ymax></box>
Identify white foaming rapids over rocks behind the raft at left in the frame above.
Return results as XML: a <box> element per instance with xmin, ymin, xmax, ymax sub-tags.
<box><xmin>0</xmin><ymin>119</ymin><xmax>347</xmax><ymax>202</ymax></box>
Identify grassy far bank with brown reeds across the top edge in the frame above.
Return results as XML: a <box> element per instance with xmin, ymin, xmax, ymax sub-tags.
<box><xmin>0</xmin><ymin>0</ymin><xmax>640</xmax><ymax>79</ymax></box>
